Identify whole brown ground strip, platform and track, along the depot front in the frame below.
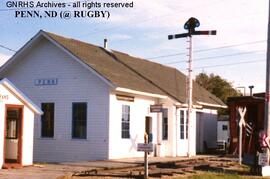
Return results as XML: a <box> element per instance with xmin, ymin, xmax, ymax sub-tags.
<box><xmin>0</xmin><ymin>155</ymin><xmax>262</xmax><ymax>179</ymax></box>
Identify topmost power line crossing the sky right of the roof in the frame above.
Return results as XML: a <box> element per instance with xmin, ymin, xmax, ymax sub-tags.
<box><xmin>146</xmin><ymin>40</ymin><xmax>266</xmax><ymax>59</ymax></box>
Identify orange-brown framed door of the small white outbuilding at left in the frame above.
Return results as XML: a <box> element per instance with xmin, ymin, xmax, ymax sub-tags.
<box><xmin>4</xmin><ymin>105</ymin><xmax>23</xmax><ymax>164</ymax></box>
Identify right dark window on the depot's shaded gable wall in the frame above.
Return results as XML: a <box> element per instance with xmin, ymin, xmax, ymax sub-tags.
<box><xmin>72</xmin><ymin>103</ymin><xmax>87</xmax><ymax>139</ymax></box>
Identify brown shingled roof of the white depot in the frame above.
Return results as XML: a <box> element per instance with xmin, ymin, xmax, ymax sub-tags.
<box><xmin>44</xmin><ymin>32</ymin><xmax>225</xmax><ymax>106</ymax></box>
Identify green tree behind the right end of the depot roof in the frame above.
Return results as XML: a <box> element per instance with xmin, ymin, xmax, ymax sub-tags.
<box><xmin>195</xmin><ymin>73</ymin><xmax>241</xmax><ymax>114</ymax></box>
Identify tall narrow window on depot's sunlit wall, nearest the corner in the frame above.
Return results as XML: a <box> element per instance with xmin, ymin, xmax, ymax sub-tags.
<box><xmin>121</xmin><ymin>105</ymin><xmax>130</xmax><ymax>139</ymax></box>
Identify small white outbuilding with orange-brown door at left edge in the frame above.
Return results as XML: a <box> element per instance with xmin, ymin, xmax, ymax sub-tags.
<box><xmin>0</xmin><ymin>78</ymin><xmax>42</xmax><ymax>168</ymax></box>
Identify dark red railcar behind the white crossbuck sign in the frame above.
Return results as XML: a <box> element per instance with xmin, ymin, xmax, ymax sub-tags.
<box><xmin>228</xmin><ymin>93</ymin><xmax>265</xmax><ymax>155</ymax></box>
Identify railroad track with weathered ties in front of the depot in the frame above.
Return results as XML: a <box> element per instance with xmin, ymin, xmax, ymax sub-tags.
<box><xmin>69</xmin><ymin>157</ymin><xmax>258</xmax><ymax>179</ymax></box>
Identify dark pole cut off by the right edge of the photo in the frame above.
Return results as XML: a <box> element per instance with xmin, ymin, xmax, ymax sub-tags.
<box><xmin>264</xmin><ymin>0</ymin><xmax>270</xmax><ymax>165</ymax></box>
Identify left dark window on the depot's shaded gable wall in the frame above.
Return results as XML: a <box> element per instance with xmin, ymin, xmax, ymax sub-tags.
<box><xmin>41</xmin><ymin>103</ymin><xmax>54</xmax><ymax>138</ymax></box>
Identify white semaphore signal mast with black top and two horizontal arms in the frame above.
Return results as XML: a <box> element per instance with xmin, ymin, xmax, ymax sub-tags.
<box><xmin>168</xmin><ymin>17</ymin><xmax>217</xmax><ymax>157</ymax></box>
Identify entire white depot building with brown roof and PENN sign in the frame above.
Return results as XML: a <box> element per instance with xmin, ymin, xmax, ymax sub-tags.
<box><xmin>0</xmin><ymin>31</ymin><xmax>226</xmax><ymax>162</ymax></box>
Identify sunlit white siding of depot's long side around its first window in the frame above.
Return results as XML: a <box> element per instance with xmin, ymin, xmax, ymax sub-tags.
<box><xmin>109</xmin><ymin>93</ymin><xmax>158</xmax><ymax>159</ymax></box>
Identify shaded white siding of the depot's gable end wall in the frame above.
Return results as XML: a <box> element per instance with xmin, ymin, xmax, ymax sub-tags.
<box><xmin>1</xmin><ymin>39</ymin><xmax>109</xmax><ymax>162</ymax></box>
